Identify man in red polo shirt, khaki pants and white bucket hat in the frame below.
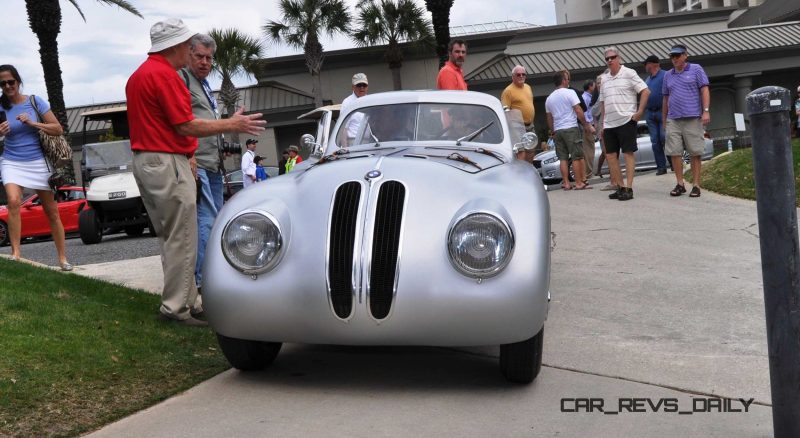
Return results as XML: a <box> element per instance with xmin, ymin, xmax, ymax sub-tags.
<box><xmin>125</xmin><ymin>18</ymin><xmax>267</xmax><ymax>326</ymax></box>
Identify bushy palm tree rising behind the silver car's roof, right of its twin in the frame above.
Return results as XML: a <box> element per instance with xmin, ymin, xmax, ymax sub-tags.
<box><xmin>353</xmin><ymin>0</ymin><xmax>432</xmax><ymax>90</ymax></box>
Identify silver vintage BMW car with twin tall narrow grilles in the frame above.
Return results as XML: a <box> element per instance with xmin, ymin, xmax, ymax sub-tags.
<box><xmin>203</xmin><ymin>91</ymin><xmax>550</xmax><ymax>382</ymax></box>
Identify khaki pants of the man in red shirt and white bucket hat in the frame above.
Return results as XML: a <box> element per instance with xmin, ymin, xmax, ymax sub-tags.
<box><xmin>133</xmin><ymin>152</ymin><xmax>200</xmax><ymax>319</ymax></box>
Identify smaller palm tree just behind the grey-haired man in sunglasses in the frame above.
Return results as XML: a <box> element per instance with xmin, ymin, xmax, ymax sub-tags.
<box><xmin>208</xmin><ymin>28</ymin><xmax>264</xmax><ymax>143</ymax></box>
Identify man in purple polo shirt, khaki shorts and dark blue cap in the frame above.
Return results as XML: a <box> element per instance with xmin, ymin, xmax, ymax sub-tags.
<box><xmin>661</xmin><ymin>44</ymin><xmax>711</xmax><ymax>198</ymax></box>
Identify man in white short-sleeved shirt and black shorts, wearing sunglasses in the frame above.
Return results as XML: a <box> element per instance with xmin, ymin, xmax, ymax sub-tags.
<box><xmin>598</xmin><ymin>47</ymin><xmax>650</xmax><ymax>201</ymax></box>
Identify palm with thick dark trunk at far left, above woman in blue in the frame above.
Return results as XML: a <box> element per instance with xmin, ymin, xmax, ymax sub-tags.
<box><xmin>25</xmin><ymin>0</ymin><xmax>143</xmax><ymax>132</ymax></box>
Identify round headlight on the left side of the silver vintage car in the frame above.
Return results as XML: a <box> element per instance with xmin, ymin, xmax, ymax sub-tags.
<box><xmin>222</xmin><ymin>212</ymin><xmax>283</xmax><ymax>274</ymax></box>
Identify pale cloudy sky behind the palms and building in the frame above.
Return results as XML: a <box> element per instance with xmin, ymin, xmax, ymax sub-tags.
<box><xmin>6</xmin><ymin>0</ymin><xmax>555</xmax><ymax>107</ymax></box>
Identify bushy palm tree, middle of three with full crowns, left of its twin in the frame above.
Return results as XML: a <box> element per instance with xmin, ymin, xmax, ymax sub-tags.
<box><xmin>263</xmin><ymin>0</ymin><xmax>350</xmax><ymax>107</ymax></box>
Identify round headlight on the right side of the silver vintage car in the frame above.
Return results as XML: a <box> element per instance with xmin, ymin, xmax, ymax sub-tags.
<box><xmin>447</xmin><ymin>213</ymin><xmax>514</xmax><ymax>278</ymax></box>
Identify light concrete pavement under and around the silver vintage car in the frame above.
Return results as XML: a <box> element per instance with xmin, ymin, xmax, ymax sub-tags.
<box><xmin>76</xmin><ymin>174</ymin><xmax>772</xmax><ymax>437</ymax></box>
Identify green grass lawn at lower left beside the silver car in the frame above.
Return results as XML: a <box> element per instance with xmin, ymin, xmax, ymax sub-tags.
<box><xmin>0</xmin><ymin>259</ymin><xmax>229</xmax><ymax>436</ymax></box>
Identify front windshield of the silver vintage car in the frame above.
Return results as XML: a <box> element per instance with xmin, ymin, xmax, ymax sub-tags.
<box><xmin>336</xmin><ymin>103</ymin><xmax>503</xmax><ymax>148</ymax></box>
